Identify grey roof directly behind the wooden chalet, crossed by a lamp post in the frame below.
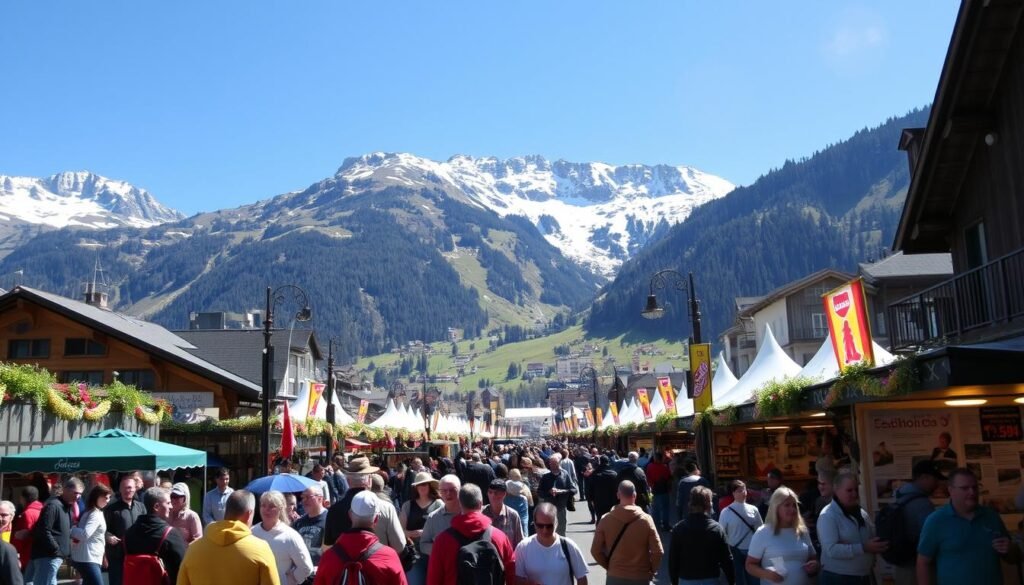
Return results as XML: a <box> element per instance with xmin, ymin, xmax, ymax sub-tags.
<box><xmin>174</xmin><ymin>329</ymin><xmax>322</xmax><ymax>387</ymax></box>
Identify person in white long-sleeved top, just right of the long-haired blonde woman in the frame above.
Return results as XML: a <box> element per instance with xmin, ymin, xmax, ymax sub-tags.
<box><xmin>818</xmin><ymin>473</ymin><xmax>889</xmax><ymax>585</ymax></box>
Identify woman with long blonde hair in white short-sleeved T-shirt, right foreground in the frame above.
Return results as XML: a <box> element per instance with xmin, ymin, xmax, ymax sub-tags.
<box><xmin>746</xmin><ymin>486</ymin><xmax>818</xmax><ymax>585</ymax></box>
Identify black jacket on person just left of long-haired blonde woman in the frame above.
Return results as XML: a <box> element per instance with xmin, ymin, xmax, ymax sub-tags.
<box><xmin>669</xmin><ymin>514</ymin><xmax>736</xmax><ymax>585</ymax></box>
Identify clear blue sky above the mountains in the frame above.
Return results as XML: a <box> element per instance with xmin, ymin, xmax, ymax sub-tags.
<box><xmin>0</xmin><ymin>0</ymin><xmax>958</xmax><ymax>213</ymax></box>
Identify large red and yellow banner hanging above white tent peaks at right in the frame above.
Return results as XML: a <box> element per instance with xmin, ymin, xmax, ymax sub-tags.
<box><xmin>821</xmin><ymin>279</ymin><xmax>874</xmax><ymax>372</ymax></box>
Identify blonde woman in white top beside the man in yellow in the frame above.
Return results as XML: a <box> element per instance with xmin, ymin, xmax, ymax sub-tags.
<box><xmin>253</xmin><ymin>490</ymin><xmax>313</xmax><ymax>585</ymax></box>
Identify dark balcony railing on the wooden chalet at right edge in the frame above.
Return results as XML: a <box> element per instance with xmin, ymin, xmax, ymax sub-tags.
<box><xmin>887</xmin><ymin>248</ymin><xmax>1024</xmax><ymax>349</ymax></box>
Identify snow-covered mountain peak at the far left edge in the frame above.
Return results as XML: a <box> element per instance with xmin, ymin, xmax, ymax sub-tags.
<box><xmin>0</xmin><ymin>172</ymin><xmax>184</xmax><ymax>229</ymax></box>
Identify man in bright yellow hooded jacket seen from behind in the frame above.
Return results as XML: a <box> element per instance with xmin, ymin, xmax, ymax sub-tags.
<box><xmin>177</xmin><ymin>490</ymin><xmax>281</xmax><ymax>585</ymax></box>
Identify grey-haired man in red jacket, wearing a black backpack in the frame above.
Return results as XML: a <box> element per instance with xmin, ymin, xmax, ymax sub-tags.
<box><xmin>427</xmin><ymin>484</ymin><xmax>516</xmax><ymax>585</ymax></box>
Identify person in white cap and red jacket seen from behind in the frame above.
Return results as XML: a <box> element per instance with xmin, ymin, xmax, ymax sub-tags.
<box><xmin>313</xmin><ymin>493</ymin><xmax>409</xmax><ymax>585</ymax></box>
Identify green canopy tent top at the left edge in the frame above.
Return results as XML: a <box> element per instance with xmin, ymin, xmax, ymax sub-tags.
<box><xmin>0</xmin><ymin>428</ymin><xmax>206</xmax><ymax>473</ymax></box>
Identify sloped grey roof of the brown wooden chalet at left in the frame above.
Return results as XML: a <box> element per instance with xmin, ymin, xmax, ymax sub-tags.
<box><xmin>0</xmin><ymin>286</ymin><xmax>261</xmax><ymax>401</ymax></box>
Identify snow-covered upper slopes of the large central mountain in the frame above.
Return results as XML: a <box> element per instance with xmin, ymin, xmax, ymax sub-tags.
<box><xmin>331</xmin><ymin>153</ymin><xmax>734</xmax><ymax>277</ymax></box>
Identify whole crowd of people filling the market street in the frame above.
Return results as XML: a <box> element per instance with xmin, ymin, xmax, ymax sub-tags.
<box><xmin>0</xmin><ymin>441</ymin><xmax>1021</xmax><ymax>585</ymax></box>
